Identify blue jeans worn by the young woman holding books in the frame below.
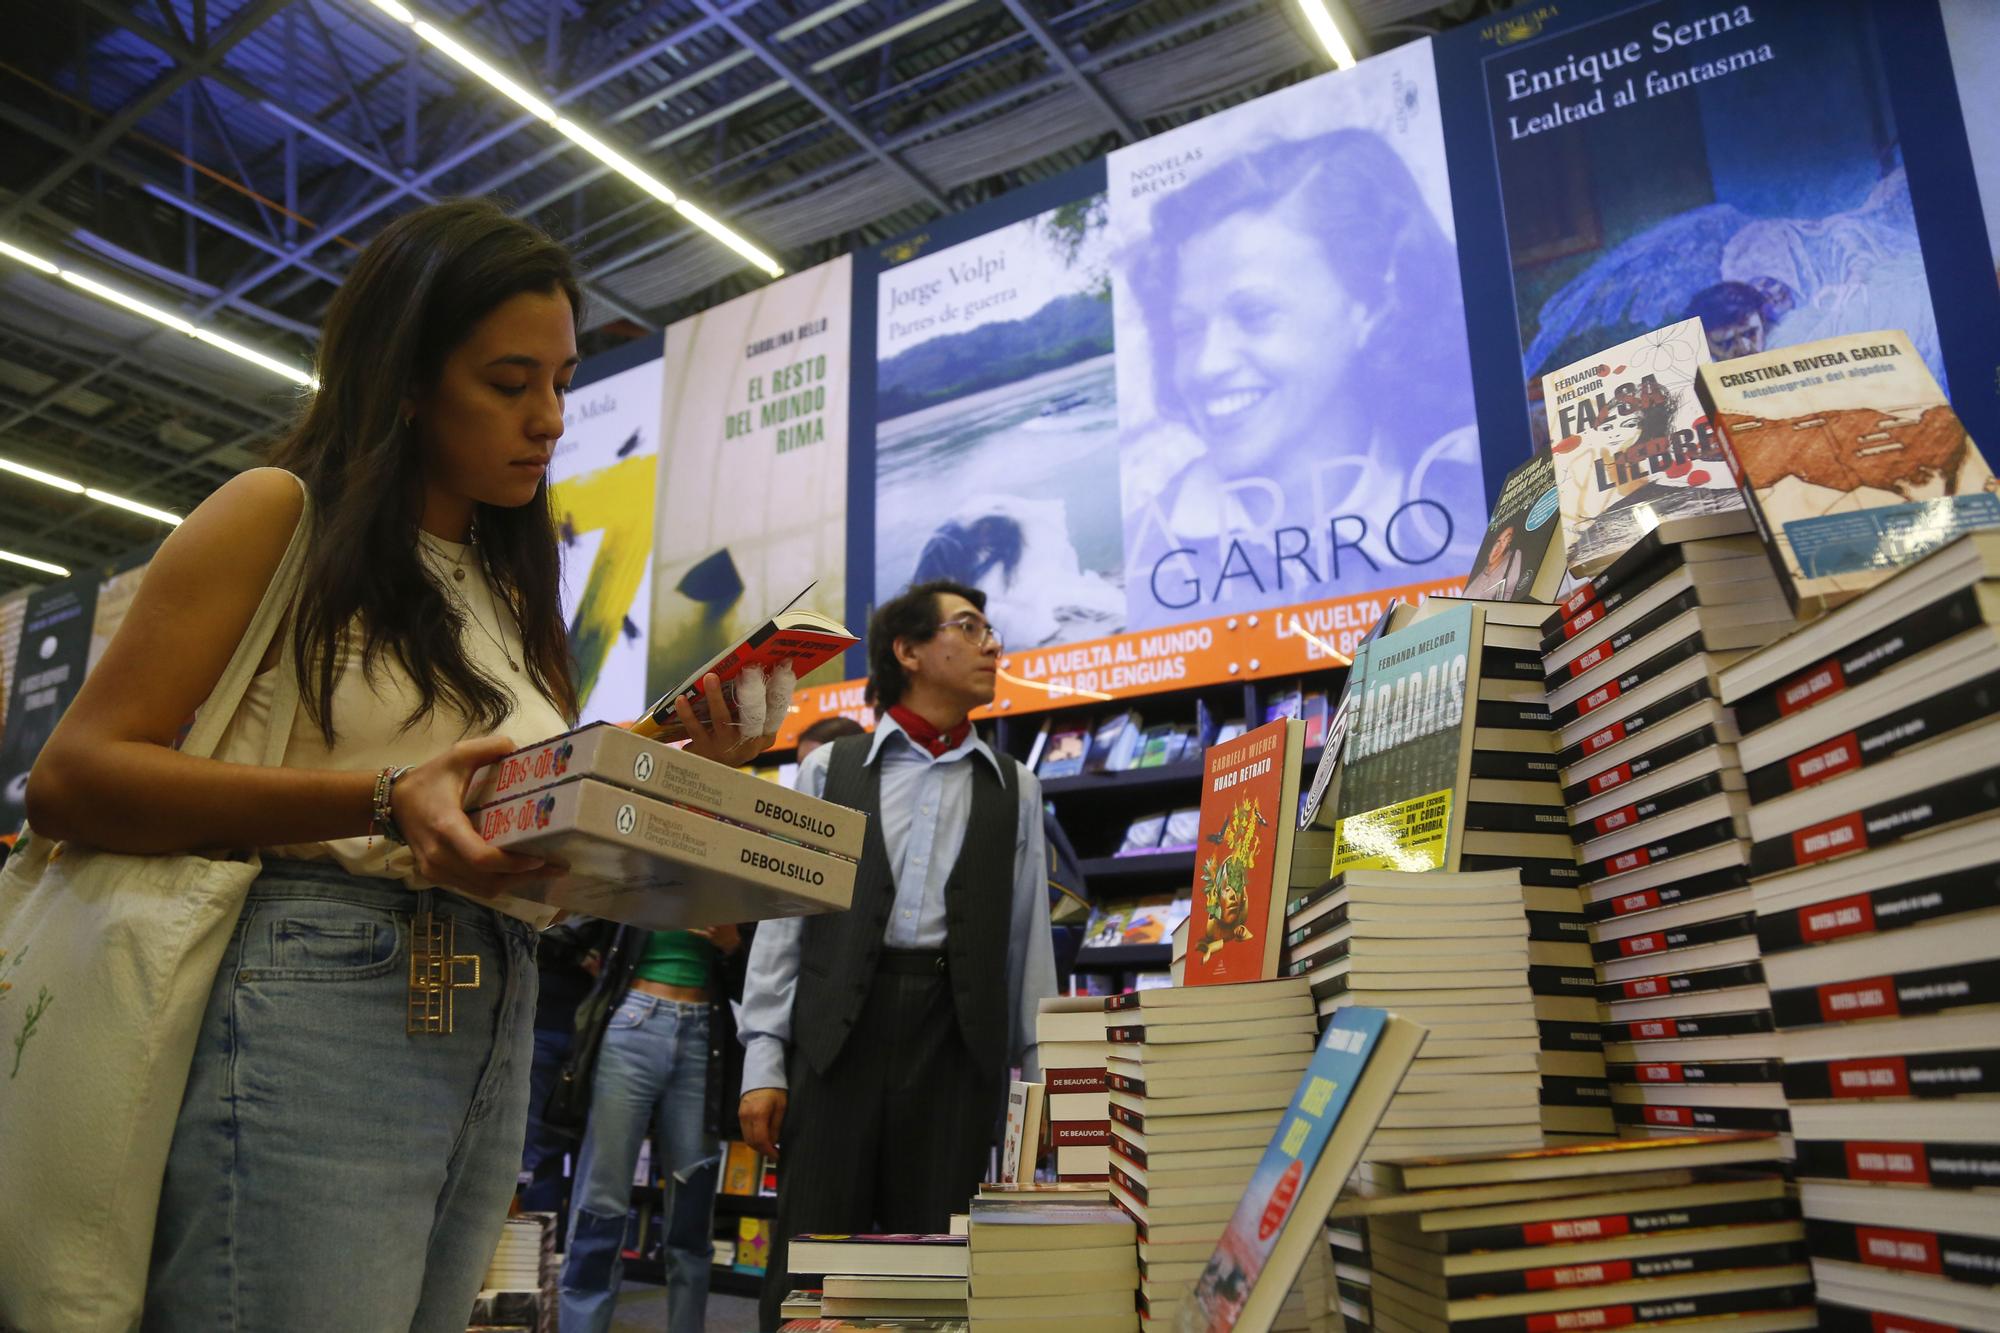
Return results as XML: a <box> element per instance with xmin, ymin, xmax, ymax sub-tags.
<box><xmin>144</xmin><ymin>861</ymin><xmax>538</xmax><ymax>1333</ymax></box>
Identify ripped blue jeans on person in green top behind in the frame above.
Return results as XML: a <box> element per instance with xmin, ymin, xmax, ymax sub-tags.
<box><xmin>562</xmin><ymin>991</ymin><xmax>720</xmax><ymax>1333</ymax></box>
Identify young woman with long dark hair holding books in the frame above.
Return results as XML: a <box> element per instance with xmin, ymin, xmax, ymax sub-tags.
<box><xmin>28</xmin><ymin>200</ymin><xmax>760</xmax><ymax>1333</ymax></box>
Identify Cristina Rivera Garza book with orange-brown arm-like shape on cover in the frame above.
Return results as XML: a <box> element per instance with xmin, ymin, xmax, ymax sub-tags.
<box><xmin>1698</xmin><ymin>330</ymin><xmax>2000</xmax><ymax>618</ymax></box>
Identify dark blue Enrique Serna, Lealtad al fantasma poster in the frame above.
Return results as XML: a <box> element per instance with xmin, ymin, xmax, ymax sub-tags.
<box><xmin>1496</xmin><ymin>0</ymin><xmax>1944</xmax><ymax>430</ymax></box>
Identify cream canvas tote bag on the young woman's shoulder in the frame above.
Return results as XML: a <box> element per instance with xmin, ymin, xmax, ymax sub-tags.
<box><xmin>0</xmin><ymin>472</ymin><xmax>312</xmax><ymax>1333</ymax></box>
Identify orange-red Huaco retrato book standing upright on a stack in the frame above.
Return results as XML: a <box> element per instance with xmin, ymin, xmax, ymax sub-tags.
<box><xmin>1184</xmin><ymin>719</ymin><xmax>1306</xmax><ymax>987</ymax></box>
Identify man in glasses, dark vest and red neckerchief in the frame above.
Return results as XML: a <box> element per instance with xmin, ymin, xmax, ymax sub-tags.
<box><xmin>738</xmin><ymin>580</ymin><xmax>1056</xmax><ymax>1329</ymax></box>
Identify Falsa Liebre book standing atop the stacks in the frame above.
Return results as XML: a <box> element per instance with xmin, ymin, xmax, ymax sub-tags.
<box><xmin>1542</xmin><ymin>318</ymin><xmax>1742</xmax><ymax>578</ymax></box>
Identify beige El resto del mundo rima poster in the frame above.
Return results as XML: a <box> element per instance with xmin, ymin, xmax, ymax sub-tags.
<box><xmin>646</xmin><ymin>256</ymin><xmax>852</xmax><ymax>695</ymax></box>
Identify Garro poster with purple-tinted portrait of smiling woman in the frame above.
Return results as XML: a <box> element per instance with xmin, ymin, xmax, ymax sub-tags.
<box><xmin>1108</xmin><ymin>42</ymin><xmax>1486</xmax><ymax>628</ymax></box>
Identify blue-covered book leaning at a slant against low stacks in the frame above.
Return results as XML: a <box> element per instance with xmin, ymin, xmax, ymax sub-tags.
<box><xmin>1174</xmin><ymin>1007</ymin><xmax>1424</xmax><ymax>1333</ymax></box>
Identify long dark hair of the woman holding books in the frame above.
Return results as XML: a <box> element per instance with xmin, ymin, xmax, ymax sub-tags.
<box><xmin>272</xmin><ymin>200</ymin><xmax>582</xmax><ymax>745</ymax></box>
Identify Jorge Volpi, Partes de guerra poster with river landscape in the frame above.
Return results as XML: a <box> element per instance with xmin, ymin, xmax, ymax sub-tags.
<box><xmin>874</xmin><ymin>194</ymin><xmax>1126</xmax><ymax>648</ymax></box>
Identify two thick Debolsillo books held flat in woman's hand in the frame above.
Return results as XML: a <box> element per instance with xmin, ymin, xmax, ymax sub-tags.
<box><xmin>466</xmin><ymin>723</ymin><xmax>868</xmax><ymax>929</ymax></box>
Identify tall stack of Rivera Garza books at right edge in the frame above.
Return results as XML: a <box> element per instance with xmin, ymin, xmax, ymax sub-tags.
<box><xmin>1722</xmin><ymin>530</ymin><xmax>2000</xmax><ymax>1329</ymax></box>
